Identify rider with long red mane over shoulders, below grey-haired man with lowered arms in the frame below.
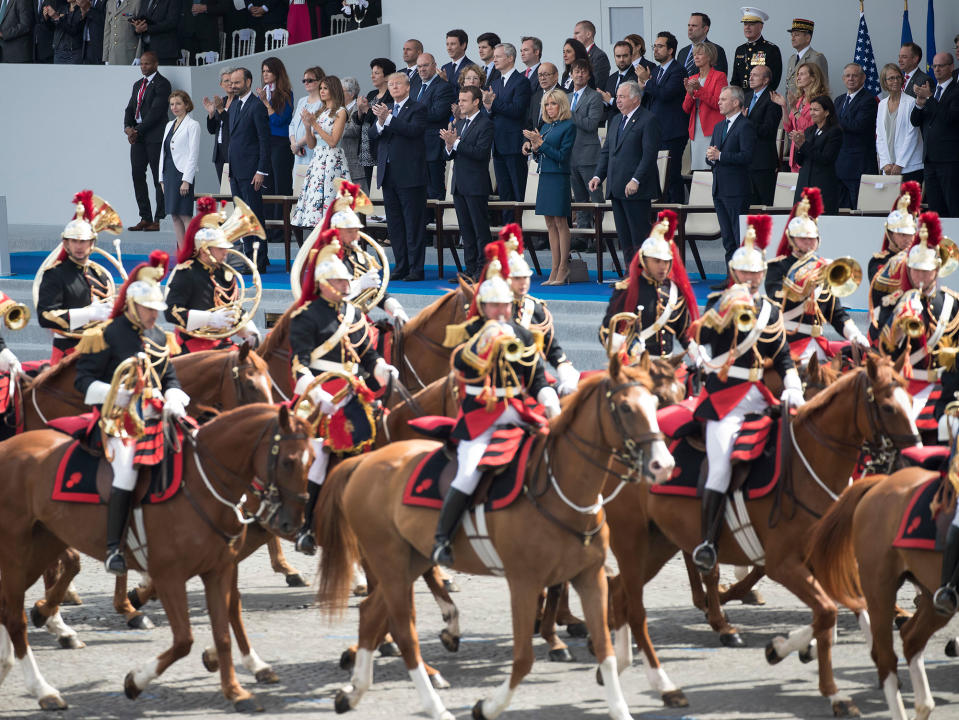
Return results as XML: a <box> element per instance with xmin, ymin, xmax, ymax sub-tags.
<box><xmin>600</xmin><ymin>210</ymin><xmax>699</xmax><ymax>358</ymax></box>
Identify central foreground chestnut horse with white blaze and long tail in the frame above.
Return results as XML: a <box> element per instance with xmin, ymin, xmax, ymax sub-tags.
<box><xmin>317</xmin><ymin>357</ymin><xmax>673</xmax><ymax>720</ymax></box>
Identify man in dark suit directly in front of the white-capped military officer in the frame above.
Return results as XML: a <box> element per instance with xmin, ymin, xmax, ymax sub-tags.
<box><xmin>745</xmin><ymin>65</ymin><xmax>782</xmax><ymax>205</ymax></box>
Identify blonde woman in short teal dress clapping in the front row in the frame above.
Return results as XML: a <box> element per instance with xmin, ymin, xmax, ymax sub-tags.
<box><xmin>523</xmin><ymin>88</ymin><xmax>576</xmax><ymax>285</ymax></box>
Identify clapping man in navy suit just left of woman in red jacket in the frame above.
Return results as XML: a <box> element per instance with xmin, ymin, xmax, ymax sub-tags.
<box><xmin>636</xmin><ymin>30</ymin><xmax>689</xmax><ymax>202</ymax></box>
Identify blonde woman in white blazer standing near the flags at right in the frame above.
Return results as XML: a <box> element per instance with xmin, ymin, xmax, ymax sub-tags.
<box><xmin>876</xmin><ymin>63</ymin><xmax>922</xmax><ymax>184</ymax></box>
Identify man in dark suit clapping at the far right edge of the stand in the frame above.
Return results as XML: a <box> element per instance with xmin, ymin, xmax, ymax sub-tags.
<box><xmin>909</xmin><ymin>53</ymin><xmax>959</xmax><ymax>217</ymax></box>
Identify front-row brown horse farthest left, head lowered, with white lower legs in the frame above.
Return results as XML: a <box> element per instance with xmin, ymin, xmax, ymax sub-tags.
<box><xmin>0</xmin><ymin>404</ymin><xmax>313</xmax><ymax>711</ymax></box>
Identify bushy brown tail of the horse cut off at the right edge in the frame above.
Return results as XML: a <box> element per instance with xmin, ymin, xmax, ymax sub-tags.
<box><xmin>806</xmin><ymin>475</ymin><xmax>886</xmax><ymax>610</ymax></box>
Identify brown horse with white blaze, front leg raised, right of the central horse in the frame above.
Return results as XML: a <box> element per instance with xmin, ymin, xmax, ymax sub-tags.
<box><xmin>606</xmin><ymin>356</ymin><xmax>918</xmax><ymax>715</ymax></box>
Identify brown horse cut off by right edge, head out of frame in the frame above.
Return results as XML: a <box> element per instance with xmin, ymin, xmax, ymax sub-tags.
<box><xmin>809</xmin><ymin>453</ymin><xmax>959</xmax><ymax>720</ymax></box>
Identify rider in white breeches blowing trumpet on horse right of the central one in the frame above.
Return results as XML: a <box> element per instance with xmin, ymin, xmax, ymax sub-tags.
<box><xmin>689</xmin><ymin>215</ymin><xmax>803</xmax><ymax>572</ymax></box>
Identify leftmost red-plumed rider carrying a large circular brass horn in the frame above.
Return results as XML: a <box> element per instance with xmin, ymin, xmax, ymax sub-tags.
<box><xmin>37</xmin><ymin>190</ymin><xmax>113</xmax><ymax>365</ymax></box>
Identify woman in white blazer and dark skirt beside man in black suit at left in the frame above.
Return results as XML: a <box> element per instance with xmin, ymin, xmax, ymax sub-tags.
<box><xmin>160</xmin><ymin>90</ymin><xmax>200</xmax><ymax>249</ymax></box>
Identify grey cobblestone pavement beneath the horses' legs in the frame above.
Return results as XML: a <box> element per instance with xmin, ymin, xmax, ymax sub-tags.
<box><xmin>0</xmin><ymin>544</ymin><xmax>959</xmax><ymax>720</ymax></box>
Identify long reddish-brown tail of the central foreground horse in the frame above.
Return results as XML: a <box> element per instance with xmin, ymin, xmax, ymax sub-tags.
<box><xmin>313</xmin><ymin>455</ymin><xmax>363</xmax><ymax>616</ymax></box>
